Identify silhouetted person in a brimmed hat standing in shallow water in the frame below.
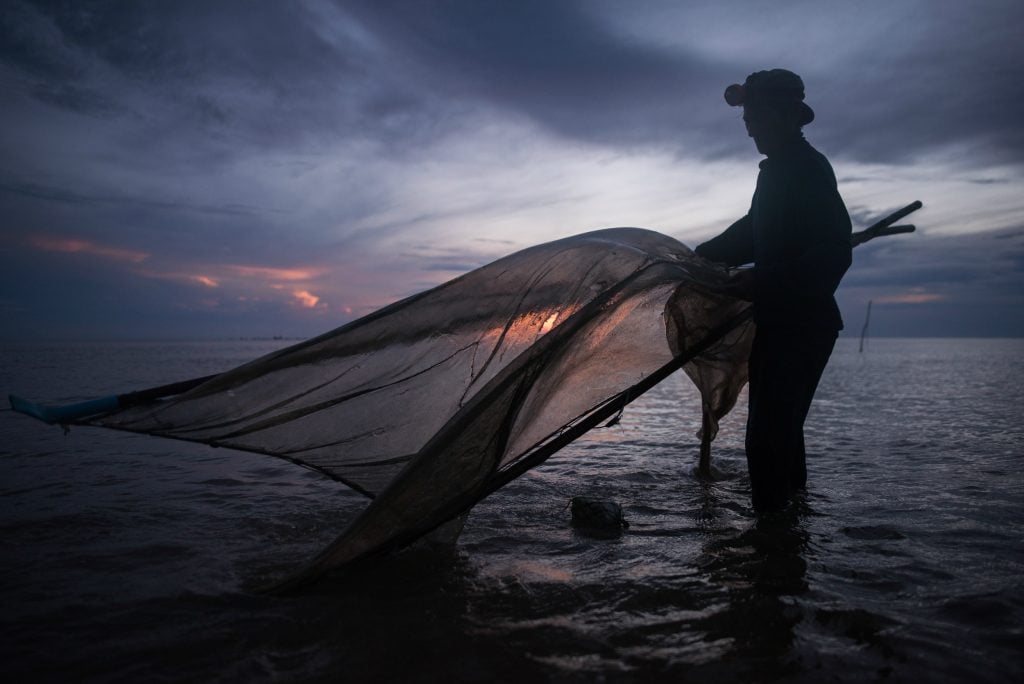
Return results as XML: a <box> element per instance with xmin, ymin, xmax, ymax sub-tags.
<box><xmin>695</xmin><ymin>69</ymin><xmax>851</xmax><ymax>513</ymax></box>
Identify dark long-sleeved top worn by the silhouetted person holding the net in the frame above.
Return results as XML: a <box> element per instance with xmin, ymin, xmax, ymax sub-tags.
<box><xmin>695</xmin><ymin>137</ymin><xmax>852</xmax><ymax>331</ymax></box>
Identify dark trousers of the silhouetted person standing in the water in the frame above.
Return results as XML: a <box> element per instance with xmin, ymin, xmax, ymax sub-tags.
<box><xmin>746</xmin><ymin>326</ymin><xmax>837</xmax><ymax>512</ymax></box>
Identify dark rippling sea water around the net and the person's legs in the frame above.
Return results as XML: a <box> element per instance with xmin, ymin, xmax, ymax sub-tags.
<box><xmin>0</xmin><ymin>340</ymin><xmax>1024</xmax><ymax>682</ymax></box>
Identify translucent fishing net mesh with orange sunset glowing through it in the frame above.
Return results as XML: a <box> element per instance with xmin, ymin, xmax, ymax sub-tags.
<box><xmin>88</xmin><ymin>228</ymin><xmax>753</xmax><ymax>580</ymax></box>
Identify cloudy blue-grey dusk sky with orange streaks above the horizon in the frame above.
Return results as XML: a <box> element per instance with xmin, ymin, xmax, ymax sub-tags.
<box><xmin>0</xmin><ymin>0</ymin><xmax>1024</xmax><ymax>339</ymax></box>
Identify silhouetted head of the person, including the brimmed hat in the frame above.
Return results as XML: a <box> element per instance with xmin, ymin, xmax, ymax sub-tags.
<box><xmin>725</xmin><ymin>69</ymin><xmax>814</xmax><ymax>156</ymax></box>
